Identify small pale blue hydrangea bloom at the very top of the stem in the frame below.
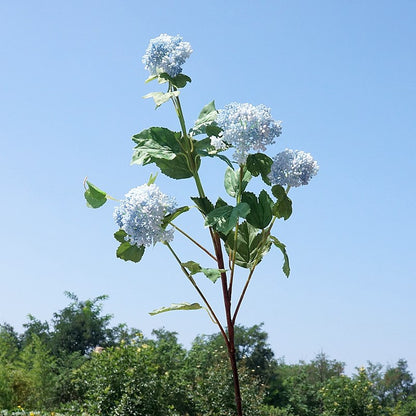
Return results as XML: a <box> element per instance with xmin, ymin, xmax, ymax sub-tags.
<box><xmin>142</xmin><ymin>34</ymin><xmax>192</xmax><ymax>78</ymax></box>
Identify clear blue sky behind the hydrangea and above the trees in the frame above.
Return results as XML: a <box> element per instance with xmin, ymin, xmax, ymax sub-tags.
<box><xmin>0</xmin><ymin>0</ymin><xmax>416</xmax><ymax>373</ymax></box>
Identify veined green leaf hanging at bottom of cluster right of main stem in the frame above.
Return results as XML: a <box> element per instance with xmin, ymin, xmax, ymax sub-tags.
<box><xmin>225</xmin><ymin>221</ymin><xmax>270</xmax><ymax>269</ymax></box>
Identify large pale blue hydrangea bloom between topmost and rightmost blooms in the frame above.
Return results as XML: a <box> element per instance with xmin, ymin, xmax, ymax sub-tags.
<box><xmin>216</xmin><ymin>102</ymin><xmax>282</xmax><ymax>165</ymax></box>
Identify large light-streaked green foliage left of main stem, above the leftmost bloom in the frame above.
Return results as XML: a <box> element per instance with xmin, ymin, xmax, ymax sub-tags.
<box><xmin>131</xmin><ymin>127</ymin><xmax>194</xmax><ymax>179</ymax></box>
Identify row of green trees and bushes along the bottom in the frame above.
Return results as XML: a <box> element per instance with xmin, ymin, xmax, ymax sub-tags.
<box><xmin>0</xmin><ymin>293</ymin><xmax>416</xmax><ymax>416</ymax></box>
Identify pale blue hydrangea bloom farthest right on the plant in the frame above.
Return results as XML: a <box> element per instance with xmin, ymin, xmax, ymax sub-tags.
<box><xmin>269</xmin><ymin>149</ymin><xmax>319</xmax><ymax>187</ymax></box>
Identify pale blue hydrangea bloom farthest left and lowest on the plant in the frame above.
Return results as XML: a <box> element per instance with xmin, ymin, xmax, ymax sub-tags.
<box><xmin>113</xmin><ymin>184</ymin><xmax>176</xmax><ymax>247</ymax></box>
